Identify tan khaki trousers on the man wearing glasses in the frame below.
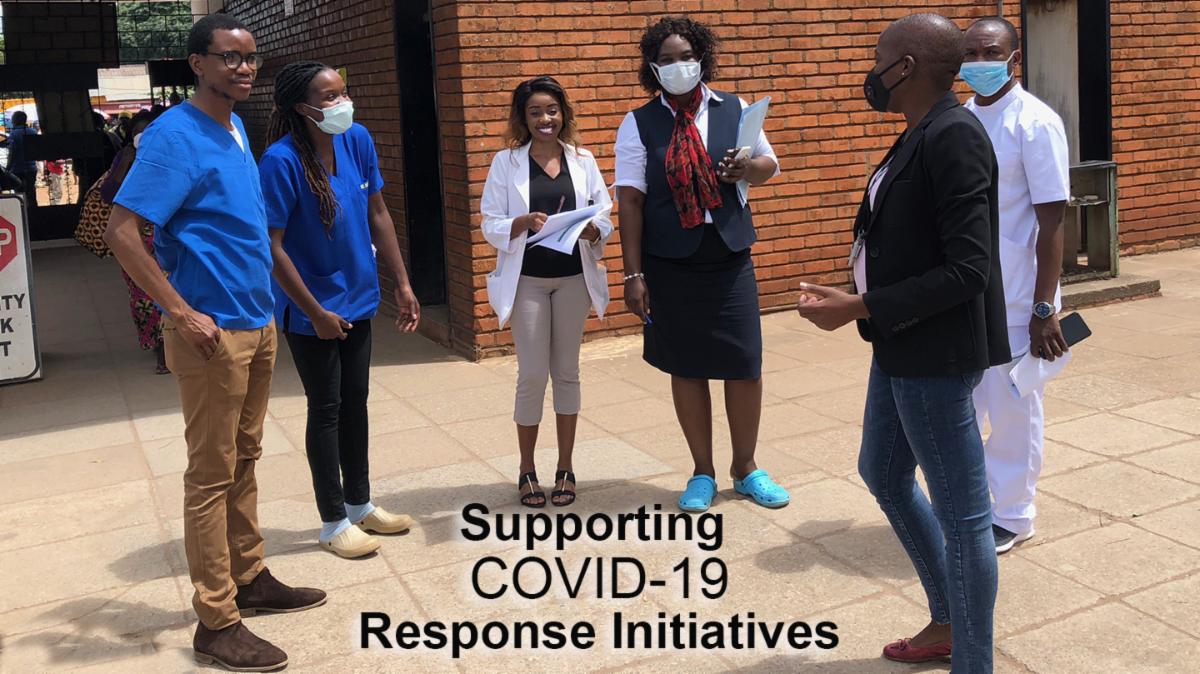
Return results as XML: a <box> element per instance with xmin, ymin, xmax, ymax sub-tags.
<box><xmin>163</xmin><ymin>318</ymin><xmax>276</xmax><ymax>630</ymax></box>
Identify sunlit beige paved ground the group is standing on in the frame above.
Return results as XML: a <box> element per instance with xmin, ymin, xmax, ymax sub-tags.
<box><xmin>0</xmin><ymin>243</ymin><xmax>1200</xmax><ymax>674</ymax></box>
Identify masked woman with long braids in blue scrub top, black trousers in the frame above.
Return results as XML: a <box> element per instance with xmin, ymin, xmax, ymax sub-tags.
<box><xmin>259</xmin><ymin>61</ymin><xmax>420</xmax><ymax>558</ymax></box>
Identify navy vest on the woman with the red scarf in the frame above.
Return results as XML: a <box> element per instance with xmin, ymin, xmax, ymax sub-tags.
<box><xmin>634</xmin><ymin>90</ymin><xmax>756</xmax><ymax>258</ymax></box>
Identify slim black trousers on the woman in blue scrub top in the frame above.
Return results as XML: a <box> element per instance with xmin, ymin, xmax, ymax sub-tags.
<box><xmin>284</xmin><ymin>320</ymin><xmax>371</xmax><ymax>522</ymax></box>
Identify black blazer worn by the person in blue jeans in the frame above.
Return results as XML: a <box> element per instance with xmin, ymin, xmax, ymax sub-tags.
<box><xmin>854</xmin><ymin>94</ymin><xmax>1012</xmax><ymax>377</ymax></box>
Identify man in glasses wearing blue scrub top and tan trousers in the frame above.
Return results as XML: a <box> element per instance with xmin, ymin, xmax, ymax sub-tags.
<box><xmin>104</xmin><ymin>14</ymin><xmax>325</xmax><ymax>672</ymax></box>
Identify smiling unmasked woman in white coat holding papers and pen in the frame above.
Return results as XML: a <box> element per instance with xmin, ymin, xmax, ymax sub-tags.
<box><xmin>481</xmin><ymin>77</ymin><xmax>612</xmax><ymax>507</ymax></box>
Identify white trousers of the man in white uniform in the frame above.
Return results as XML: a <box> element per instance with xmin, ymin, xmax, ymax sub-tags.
<box><xmin>974</xmin><ymin>327</ymin><xmax>1045</xmax><ymax>534</ymax></box>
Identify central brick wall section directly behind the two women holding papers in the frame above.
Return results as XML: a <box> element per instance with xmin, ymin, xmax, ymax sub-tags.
<box><xmin>436</xmin><ymin>0</ymin><xmax>1016</xmax><ymax>354</ymax></box>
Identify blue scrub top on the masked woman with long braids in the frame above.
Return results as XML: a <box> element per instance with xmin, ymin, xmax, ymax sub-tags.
<box><xmin>258</xmin><ymin>124</ymin><xmax>383</xmax><ymax>335</ymax></box>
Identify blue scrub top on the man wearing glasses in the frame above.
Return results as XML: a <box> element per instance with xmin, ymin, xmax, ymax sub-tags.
<box><xmin>114</xmin><ymin>102</ymin><xmax>275</xmax><ymax>330</ymax></box>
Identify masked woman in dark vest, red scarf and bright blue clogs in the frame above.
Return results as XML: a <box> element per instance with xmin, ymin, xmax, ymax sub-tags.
<box><xmin>616</xmin><ymin>17</ymin><xmax>790</xmax><ymax>512</ymax></box>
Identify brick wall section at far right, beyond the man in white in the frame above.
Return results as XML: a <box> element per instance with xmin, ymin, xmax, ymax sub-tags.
<box><xmin>1112</xmin><ymin>0</ymin><xmax>1200</xmax><ymax>253</ymax></box>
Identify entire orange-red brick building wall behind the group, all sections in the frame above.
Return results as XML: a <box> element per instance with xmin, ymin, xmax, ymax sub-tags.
<box><xmin>218</xmin><ymin>0</ymin><xmax>1200</xmax><ymax>357</ymax></box>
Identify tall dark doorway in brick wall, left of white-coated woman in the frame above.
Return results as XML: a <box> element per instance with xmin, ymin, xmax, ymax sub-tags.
<box><xmin>396</xmin><ymin>0</ymin><xmax>446</xmax><ymax>306</ymax></box>
